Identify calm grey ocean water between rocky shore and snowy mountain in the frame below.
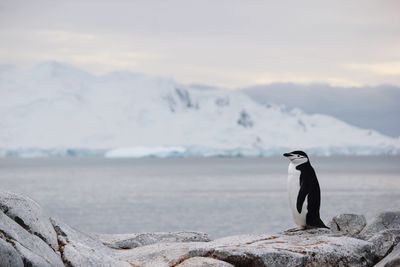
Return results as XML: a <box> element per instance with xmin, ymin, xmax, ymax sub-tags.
<box><xmin>0</xmin><ymin>156</ymin><xmax>400</xmax><ymax>238</ymax></box>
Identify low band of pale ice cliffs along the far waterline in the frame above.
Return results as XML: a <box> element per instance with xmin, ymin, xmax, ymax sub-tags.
<box><xmin>0</xmin><ymin>146</ymin><xmax>400</xmax><ymax>159</ymax></box>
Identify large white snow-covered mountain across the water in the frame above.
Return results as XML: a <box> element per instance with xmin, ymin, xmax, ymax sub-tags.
<box><xmin>0</xmin><ymin>63</ymin><xmax>400</xmax><ymax>157</ymax></box>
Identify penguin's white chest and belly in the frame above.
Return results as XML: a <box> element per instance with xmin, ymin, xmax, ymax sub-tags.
<box><xmin>288</xmin><ymin>163</ymin><xmax>307</xmax><ymax>228</ymax></box>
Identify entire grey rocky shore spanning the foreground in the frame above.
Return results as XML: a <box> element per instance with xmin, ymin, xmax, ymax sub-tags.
<box><xmin>0</xmin><ymin>192</ymin><xmax>400</xmax><ymax>267</ymax></box>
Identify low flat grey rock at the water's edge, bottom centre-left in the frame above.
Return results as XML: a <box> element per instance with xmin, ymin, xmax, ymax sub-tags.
<box><xmin>94</xmin><ymin>232</ymin><xmax>210</xmax><ymax>249</ymax></box>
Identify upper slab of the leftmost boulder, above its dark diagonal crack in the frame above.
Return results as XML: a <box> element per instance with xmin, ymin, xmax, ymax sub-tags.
<box><xmin>0</xmin><ymin>191</ymin><xmax>58</xmax><ymax>250</ymax></box>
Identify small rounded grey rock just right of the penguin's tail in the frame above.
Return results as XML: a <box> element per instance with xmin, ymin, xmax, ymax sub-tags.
<box><xmin>328</xmin><ymin>214</ymin><xmax>367</xmax><ymax>236</ymax></box>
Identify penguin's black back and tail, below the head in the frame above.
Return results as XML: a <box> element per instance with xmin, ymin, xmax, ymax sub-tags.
<box><xmin>296</xmin><ymin>162</ymin><xmax>328</xmax><ymax>228</ymax></box>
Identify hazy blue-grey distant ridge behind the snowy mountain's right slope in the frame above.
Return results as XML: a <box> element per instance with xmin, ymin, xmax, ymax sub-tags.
<box><xmin>242</xmin><ymin>83</ymin><xmax>400</xmax><ymax>137</ymax></box>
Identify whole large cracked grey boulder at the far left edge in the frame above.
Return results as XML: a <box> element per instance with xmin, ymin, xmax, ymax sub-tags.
<box><xmin>0</xmin><ymin>192</ymin><xmax>64</xmax><ymax>266</ymax></box>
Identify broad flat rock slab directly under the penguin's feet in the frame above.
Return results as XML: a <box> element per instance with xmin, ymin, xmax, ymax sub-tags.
<box><xmin>211</xmin><ymin>229</ymin><xmax>374</xmax><ymax>266</ymax></box>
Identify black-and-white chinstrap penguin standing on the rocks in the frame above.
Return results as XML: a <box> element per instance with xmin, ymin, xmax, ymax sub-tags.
<box><xmin>283</xmin><ymin>150</ymin><xmax>329</xmax><ymax>230</ymax></box>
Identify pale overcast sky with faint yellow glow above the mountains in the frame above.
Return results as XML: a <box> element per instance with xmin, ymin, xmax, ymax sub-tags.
<box><xmin>0</xmin><ymin>0</ymin><xmax>400</xmax><ymax>88</ymax></box>
